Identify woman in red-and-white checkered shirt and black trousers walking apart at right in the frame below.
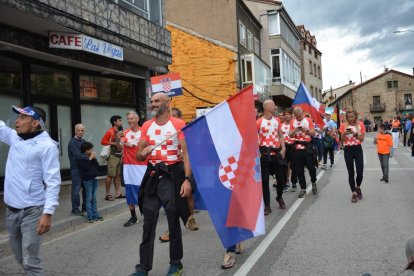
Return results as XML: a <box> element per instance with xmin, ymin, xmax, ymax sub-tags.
<box><xmin>339</xmin><ymin>108</ymin><xmax>365</xmax><ymax>203</ymax></box>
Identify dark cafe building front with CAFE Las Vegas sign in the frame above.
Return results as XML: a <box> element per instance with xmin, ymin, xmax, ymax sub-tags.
<box><xmin>0</xmin><ymin>0</ymin><xmax>172</xmax><ymax>188</ymax></box>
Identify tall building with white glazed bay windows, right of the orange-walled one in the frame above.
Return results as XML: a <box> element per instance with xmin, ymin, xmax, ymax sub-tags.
<box><xmin>244</xmin><ymin>0</ymin><xmax>301</xmax><ymax>111</ymax></box>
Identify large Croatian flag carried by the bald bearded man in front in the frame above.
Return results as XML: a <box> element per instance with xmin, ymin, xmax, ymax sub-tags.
<box><xmin>183</xmin><ymin>86</ymin><xmax>265</xmax><ymax>248</ymax></box>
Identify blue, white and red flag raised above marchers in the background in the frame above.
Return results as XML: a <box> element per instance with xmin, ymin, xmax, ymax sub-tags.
<box><xmin>292</xmin><ymin>82</ymin><xmax>324</xmax><ymax>128</ymax></box>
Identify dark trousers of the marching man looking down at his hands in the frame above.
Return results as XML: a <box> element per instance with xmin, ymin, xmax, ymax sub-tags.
<box><xmin>293</xmin><ymin>149</ymin><xmax>316</xmax><ymax>189</ymax></box>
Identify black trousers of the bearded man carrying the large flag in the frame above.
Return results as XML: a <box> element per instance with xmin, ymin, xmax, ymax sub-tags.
<box><xmin>135</xmin><ymin>176</ymin><xmax>183</xmax><ymax>271</ymax></box>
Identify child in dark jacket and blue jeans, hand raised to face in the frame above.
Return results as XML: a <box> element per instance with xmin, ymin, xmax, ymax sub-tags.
<box><xmin>78</xmin><ymin>142</ymin><xmax>103</xmax><ymax>223</ymax></box>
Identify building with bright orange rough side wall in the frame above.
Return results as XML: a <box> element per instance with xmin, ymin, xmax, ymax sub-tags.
<box><xmin>166</xmin><ymin>0</ymin><xmax>270</xmax><ymax>121</ymax></box>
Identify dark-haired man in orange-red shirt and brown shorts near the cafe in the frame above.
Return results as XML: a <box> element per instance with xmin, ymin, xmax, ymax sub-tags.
<box><xmin>101</xmin><ymin>115</ymin><xmax>125</xmax><ymax>201</ymax></box>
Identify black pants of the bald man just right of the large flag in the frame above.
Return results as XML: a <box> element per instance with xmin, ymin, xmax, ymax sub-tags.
<box><xmin>260</xmin><ymin>154</ymin><xmax>286</xmax><ymax>207</ymax></box>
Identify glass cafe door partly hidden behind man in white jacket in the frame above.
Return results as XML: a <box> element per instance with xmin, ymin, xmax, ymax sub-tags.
<box><xmin>34</xmin><ymin>102</ymin><xmax>72</xmax><ymax>170</ymax></box>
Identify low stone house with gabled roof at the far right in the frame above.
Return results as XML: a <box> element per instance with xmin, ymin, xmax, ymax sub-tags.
<box><xmin>330</xmin><ymin>69</ymin><xmax>414</xmax><ymax>121</ymax></box>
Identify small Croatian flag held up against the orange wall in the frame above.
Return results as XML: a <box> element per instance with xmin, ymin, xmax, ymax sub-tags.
<box><xmin>151</xmin><ymin>73</ymin><xmax>183</xmax><ymax>97</ymax></box>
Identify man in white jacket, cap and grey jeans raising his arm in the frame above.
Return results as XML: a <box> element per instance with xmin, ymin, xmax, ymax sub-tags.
<box><xmin>0</xmin><ymin>106</ymin><xmax>61</xmax><ymax>275</ymax></box>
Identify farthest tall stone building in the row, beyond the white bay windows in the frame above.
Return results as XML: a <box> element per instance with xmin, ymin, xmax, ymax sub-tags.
<box><xmin>297</xmin><ymin>25</ymin><xmax>323</xmax><ymax>102</ymax></box>
